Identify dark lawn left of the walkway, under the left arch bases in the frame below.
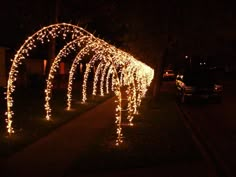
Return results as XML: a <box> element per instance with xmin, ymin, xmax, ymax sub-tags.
<box><xmin>0</xmin><ymin>83</ymin><xmax>113</xmax><ymax>158</ymax></box>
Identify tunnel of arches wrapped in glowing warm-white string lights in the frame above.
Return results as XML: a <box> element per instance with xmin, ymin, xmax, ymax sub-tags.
<box><xmin>5</xmin><ymin>23</ymin><xmax>154</xmax><ymax>145</ymax></box>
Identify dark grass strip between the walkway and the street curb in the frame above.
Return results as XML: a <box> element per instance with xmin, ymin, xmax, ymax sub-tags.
<box><xmin>64</xmin><ymin>90</ymin><xmax>201</xmax><ymax>176</ymax></box>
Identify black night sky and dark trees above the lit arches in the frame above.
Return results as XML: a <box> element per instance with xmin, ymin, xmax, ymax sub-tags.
<box><xmin>0</xmin><ymin>0</ymin><xmax>236</xmax><ymax>66</ymax></box>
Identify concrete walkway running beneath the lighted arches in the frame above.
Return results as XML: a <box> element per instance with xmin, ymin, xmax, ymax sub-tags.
<box><xmin>0</xmin><ymin>98</ymin><xmax>115</xmax><ymax>177</ymax></box>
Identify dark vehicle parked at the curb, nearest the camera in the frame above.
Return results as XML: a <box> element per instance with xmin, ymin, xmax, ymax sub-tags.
<box><xmin>176</xmin><ymin>59</ymin><xmax>223</xmax><ymax>103</ymax></box>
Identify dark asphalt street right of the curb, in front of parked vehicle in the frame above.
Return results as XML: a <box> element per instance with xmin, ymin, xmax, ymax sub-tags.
<box><xmin>176</xmin><ymin>81</ymin><xmax>236</xmax><ymax>177</ymax></box>
